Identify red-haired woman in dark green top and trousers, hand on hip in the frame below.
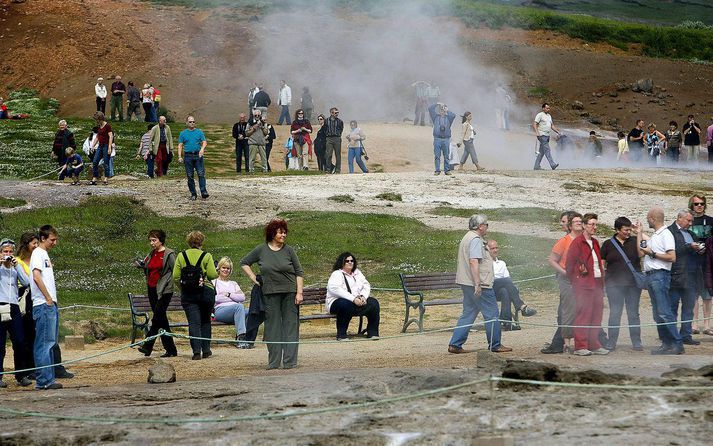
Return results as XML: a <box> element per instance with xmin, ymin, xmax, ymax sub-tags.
<box><xmin>240</xmin><ymin>218</ymin><xmax>304</xmax><ymax>369</ymax></box>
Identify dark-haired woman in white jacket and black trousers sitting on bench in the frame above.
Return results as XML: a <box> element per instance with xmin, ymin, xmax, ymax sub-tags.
<box><xmin>326</xmin><ymin>252</ymin><xmax>380</xmax><ymax>341</ymax></box>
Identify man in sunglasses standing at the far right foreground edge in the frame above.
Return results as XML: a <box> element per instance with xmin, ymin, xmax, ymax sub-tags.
<box><xmin>688</xmin><ymin>194</ymin><xmax>713</xmax><ymax>336</ymax></box>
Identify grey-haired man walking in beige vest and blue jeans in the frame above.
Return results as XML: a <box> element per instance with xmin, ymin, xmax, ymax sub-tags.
<box><xmin>448</xmin><ymin>214</ymin><xmax>512</xmax><ymax>354</ymax></box>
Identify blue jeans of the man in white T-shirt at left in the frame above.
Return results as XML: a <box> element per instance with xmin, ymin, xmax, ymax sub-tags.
<box><xmin>32</xmin><ymin>304</ymin><xmax>59</xmax><ymax>389</ymax></box>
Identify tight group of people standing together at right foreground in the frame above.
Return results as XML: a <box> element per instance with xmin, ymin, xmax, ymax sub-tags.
<box><xmin>542</xmin><ymin>194</ymin><xmax>713</xmax><ymax>356</ymax></box>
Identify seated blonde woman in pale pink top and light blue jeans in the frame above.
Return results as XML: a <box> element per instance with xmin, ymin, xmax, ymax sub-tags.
<box><xmin>213</xmin><ymin>257</ymin><xmax>253</xmax><ymax>348</ymax></box>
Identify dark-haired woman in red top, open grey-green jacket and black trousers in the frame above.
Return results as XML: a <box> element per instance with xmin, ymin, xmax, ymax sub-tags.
<box><xmin>136</xmin><ymin>229</ymin><xmax>178</xmax><ymax>358</ymax></box>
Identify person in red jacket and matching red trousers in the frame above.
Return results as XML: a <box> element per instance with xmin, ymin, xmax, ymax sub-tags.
<box><xmin>566</xmin><ymin>214</ymin><xmax>609</xmax><ymax>356</ymax></box>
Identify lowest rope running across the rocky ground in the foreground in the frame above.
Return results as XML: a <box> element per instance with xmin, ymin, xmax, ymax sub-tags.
<box><xmin>0</xmin><ymin>376</ymin><xmax>713</xmax><ymax>424</ymax></box>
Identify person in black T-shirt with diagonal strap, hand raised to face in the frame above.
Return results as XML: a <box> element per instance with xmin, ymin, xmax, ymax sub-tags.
<box><xmin>601</xmin><ymin>217</ymin><xmax>644</xmax><ymax>351</ymax></box>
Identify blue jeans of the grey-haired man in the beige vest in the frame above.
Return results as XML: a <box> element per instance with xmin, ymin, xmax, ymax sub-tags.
<box><xmin>448</xmin><ymin>285</ymin><xmax>500</xmax><ymax>350</ymax></box>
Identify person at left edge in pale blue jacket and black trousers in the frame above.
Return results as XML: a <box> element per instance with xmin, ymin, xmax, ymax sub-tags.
<box><xmin>0</xmin><ymin>239</ymin><xmax>32</xmax><ymax>388</ymax></box>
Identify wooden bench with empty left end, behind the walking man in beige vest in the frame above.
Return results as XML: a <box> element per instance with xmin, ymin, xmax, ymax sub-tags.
<box><xmin>399</xmin><ymin>273</ymin><xmax>518</xmax><ymax>333</ymax></box>
